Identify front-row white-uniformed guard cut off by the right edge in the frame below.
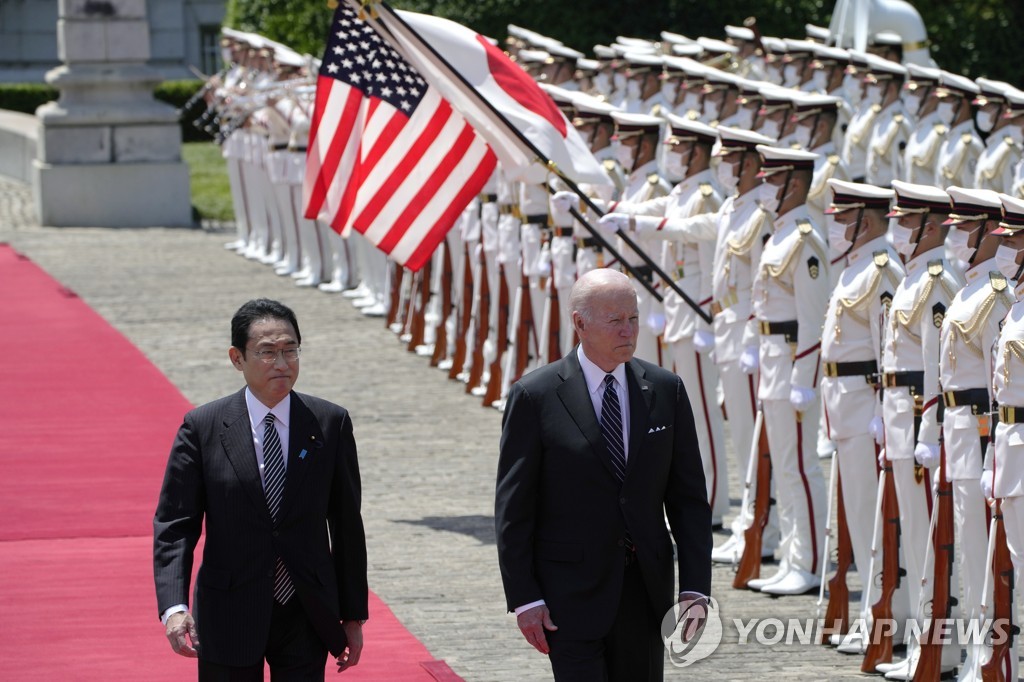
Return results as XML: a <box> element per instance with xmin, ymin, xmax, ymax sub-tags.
<box><xmin>981</xmin><ymin>195</ymin><xmax>1024</xmax><ymax>680</ymax></box>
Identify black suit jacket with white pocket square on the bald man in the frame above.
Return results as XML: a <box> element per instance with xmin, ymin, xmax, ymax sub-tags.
<box><xmin>495</xmin><ymin>350</ymin><xmax>712</xmax><ymax>639</ymax></box>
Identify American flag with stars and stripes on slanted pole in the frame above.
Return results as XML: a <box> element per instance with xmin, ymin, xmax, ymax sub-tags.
<box><xmin>303</xmin><ymin>3</ymin><xmax>495</xmax><ymax>270</ymax></box>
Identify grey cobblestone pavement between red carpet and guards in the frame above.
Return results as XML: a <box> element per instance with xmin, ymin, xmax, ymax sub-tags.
<box><xmin>0</xmin><ymin>173</ymin><xmax>913</xmax><ymax>682</ymax></box>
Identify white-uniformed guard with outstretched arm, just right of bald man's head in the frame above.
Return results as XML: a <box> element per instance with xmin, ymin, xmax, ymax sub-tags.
<box><xmin>601</xmin><ymin>114</ymin><xmax>729</xmax><ymax>524</ymax></box>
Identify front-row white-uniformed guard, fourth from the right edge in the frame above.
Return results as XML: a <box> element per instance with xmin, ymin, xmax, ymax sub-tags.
<box><xmin>821</xmin><ymin>179</ymin><xmax>903</xmax><ymax>653</ymax></box>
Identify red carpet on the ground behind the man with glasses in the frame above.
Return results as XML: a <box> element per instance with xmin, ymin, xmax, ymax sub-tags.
<box><xmin>0</xmin><ymin>244</ymin><xmax>459</xmax><ymax>682</ymax></box>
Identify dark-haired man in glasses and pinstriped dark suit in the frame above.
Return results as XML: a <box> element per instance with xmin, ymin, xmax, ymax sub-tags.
<box><xmin>154</xmin><ymin>299</ymin><xmax>368</xmax><ymax>681</ymax></box>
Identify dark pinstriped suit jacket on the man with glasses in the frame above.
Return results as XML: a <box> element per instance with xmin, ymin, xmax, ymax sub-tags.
<box><xmin>154</xmin><ymin>389</ymin><xmax>368</xmax><ymax>666</ymax></box>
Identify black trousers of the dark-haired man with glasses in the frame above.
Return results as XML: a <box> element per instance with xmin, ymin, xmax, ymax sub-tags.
<box><xmin>199</xmin><ymin>596</ymin><xmax>327</xmax><ymax>682</ymax></box>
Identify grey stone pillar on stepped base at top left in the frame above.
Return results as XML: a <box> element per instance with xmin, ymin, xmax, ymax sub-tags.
<box><xmin>33</xmin><ymin>0</ymin><xmax>191</xmax><ymax>227</ymax></box>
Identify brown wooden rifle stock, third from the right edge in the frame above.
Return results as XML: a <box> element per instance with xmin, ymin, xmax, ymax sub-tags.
<box><xmin>860</xmin><ymin>459</ymin><xmax>904</xmax><ymax>674</ymax></box>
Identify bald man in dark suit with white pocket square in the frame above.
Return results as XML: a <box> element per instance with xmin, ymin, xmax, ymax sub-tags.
<box><xmin>495</xmin><ymin>269</ymin><xmax>712</xmax><ymax>682</ymax></box>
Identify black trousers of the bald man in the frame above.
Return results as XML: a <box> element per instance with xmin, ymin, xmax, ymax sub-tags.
<box><xmin>545</xmin><ymin>560</ymin><xmax>665</xmax><ymax>682</ymax></box>
